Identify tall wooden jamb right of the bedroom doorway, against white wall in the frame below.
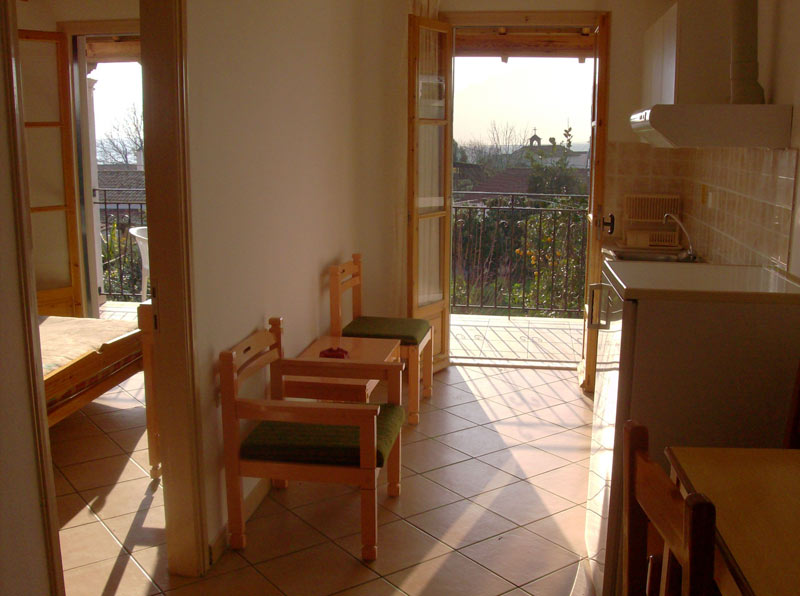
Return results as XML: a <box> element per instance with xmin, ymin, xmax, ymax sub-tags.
<box><xmin>139</xmin><ymin>0</ymin><xmax>210</xmax><ymax>577</ymax></box>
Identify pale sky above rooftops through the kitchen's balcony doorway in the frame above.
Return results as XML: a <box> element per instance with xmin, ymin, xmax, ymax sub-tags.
<box><xmin>453</xmin><ymin>58</ymin><xmax>593</xmax><ymax>145</ymax></box>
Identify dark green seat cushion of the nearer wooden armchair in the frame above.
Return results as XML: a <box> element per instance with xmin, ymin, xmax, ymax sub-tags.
<box><xmin>240</xmin><ymin>404</ymin><xmax>406</xmax><ymax>468</ymax></box>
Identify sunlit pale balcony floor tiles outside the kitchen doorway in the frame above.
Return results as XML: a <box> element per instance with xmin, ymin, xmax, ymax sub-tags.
<box><xmin>450</xmin><ymin>314</ymin><xmax>583</xmax><ymax>366</ymax></box>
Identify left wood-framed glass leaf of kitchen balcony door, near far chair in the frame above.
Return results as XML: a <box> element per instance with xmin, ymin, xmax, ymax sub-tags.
<box><xmin>407</xmin><ymin>15</ymin><xmax>453</xmax><ymax>370</ymax></box>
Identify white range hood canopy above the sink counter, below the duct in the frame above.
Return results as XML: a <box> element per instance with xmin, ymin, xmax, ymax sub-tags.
<box><xmin>631</xmin><ymin>104</ymin><xmax>792</xmax><ymax>149</ymax></box>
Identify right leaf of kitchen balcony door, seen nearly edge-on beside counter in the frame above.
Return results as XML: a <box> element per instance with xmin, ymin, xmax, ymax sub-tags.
<box><xmin>578</xmin><ymin>13</ymin><xmax>611</xmax><ymax>393</ymax></box>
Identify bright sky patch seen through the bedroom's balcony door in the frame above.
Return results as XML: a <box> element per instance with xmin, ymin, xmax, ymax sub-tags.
<box><xmin>89</xmin><ymin>62</ymin><xmax>142</xmax><ymax>140</ymax></box>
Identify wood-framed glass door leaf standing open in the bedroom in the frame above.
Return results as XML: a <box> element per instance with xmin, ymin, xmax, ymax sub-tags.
<box><xmin>19</xmin><ymin>30</ymin><xmax>83</xmax><ymax>317</ymax></box>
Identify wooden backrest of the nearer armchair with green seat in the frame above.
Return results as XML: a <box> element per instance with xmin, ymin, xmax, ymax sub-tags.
<box><xmin>219</xmin><ymin>317</ymin><xmax>283</xmax><ymax>443</ymax></box>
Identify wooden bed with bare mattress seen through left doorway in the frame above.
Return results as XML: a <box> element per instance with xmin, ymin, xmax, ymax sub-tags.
<box><xmin>39</xmin><ymin>304</ymin><xmax>160</xmax><ymax>477</ymax></box>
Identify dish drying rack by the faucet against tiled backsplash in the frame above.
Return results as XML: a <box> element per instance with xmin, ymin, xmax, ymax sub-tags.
<box><xmin>623</xmin><ymin>194</ymin><xmax>681</xmax><ymax>248</ymax></box>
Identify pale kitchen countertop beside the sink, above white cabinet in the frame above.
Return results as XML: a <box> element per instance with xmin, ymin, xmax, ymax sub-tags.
<box><xmin>604</xmin><ymin>261</ymin><xmax>800</xmax><ymax>304</ymax></box>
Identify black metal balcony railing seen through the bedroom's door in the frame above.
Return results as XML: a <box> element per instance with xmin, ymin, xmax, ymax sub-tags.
<box><xmin>93</xmin><ymin>188</ymin><xmax>147</xmax><ymax>301</ymax></box>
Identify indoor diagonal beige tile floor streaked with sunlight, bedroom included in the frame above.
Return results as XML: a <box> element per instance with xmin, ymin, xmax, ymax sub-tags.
<box><xmin>51</xmin><ymin>367</ymin><xmax>593</xmax><ymax>596</ymax></box>
